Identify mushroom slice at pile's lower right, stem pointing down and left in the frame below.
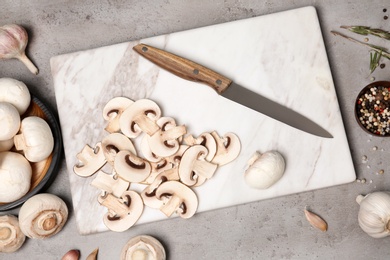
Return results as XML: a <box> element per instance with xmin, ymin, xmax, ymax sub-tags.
<box><xmin>156</xmin><ymin>181</ymin><xmax>198</xmax><ymax>218</ymax></box>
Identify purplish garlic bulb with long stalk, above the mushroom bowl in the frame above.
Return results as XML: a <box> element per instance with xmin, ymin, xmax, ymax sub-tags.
<box><xmin>0</xmin><ymin>24</ymin><xmax>38</xmax><ymax>75</ymax></box>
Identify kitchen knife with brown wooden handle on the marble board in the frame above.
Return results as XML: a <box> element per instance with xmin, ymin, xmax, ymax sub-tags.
<box><xmin>133</xmin><ymin>44</ymin><xmax>333</xmax><ymax>138</ymax></box>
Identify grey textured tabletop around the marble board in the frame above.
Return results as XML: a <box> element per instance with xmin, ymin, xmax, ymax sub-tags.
<box><xmin>0</xmin><ymin>0</ymin><xmax>390</xmax><ymax>259</ymax></box>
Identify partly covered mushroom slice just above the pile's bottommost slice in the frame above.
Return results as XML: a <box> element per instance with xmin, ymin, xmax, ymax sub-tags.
<box><xmin>91</xmin><ymin>171</ymin><xmax>130</xmax><ymax>197</ymax></box>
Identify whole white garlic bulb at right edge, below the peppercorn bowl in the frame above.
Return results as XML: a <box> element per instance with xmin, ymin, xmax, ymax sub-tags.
<box><xmin>356</xmin><ymin>191</ymin><xmax>390</xmax><ymax>238</ymax></box>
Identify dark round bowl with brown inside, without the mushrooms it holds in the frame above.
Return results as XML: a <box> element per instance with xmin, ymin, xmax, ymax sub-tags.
<box><xmin>0</xmin><ymin>96</ymin><xmax>62</xmax><ymax>211</ymax></box>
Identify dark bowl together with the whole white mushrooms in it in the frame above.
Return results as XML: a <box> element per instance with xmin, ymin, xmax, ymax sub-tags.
<box><xmin>0</xmin><ymin>78</ymin><xmax>62</xmax><ymax>211</ymax></box>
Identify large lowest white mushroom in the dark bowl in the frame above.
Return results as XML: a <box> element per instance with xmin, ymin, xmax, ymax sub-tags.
<box><xmin>0</xmin><ymin>151</ymin><xmax>32</xmax><ymax>203</ymax></box>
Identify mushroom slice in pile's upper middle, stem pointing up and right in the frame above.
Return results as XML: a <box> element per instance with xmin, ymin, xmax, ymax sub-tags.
<box><xmin>145</xmin><ymin>117</ymin><xmax>187</xmax><ymax>157</ymax></box>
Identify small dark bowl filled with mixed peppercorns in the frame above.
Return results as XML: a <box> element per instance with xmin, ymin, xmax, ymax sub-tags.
<box><xmin>355</xmin><ymin>81</ymin><xmax>390</xmax><ymax>137</ymax></box>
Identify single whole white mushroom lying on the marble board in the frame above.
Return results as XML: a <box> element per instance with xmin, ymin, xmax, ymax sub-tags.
<box><xmin>244</xmin><ymin>151</ymin><xmax>286</xmax><ymax>189</ymax></box>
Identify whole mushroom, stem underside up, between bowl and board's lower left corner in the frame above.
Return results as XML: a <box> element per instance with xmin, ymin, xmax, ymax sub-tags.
<box><xmin>19</xmin><ymin>193</ymin><xmax>68</xmax><ymax>239</ymax></box>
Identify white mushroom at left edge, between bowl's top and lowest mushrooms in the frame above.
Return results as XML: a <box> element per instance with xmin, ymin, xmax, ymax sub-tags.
<box><xmin>0</xmin><ymin>102</ymin><xmax>20</xmax><ymax>141</ymax></box>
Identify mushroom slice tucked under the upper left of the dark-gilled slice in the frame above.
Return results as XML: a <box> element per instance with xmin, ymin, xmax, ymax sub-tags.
<box><xmin>102</xmin><ymin>133</ymin><xmax>137</xmax><ymax>165</ymax></box>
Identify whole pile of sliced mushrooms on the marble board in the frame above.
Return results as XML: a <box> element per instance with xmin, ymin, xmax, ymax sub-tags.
<box><xmin>74</xmin><ymin>97</ymin><xmax>241</xmax><ymax>232</ymax></box>
